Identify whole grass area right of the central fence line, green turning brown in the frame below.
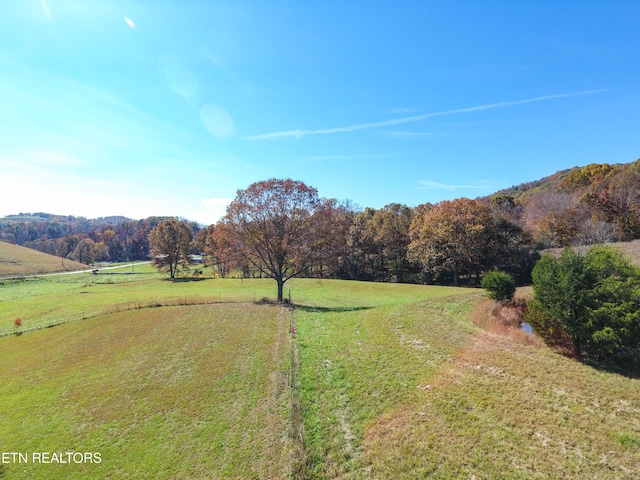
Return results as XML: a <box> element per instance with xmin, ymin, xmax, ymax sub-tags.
<box><xmin>296</xmin><ymin>290</ymin><xmax>640</xmax><ymax>479</ymax></box>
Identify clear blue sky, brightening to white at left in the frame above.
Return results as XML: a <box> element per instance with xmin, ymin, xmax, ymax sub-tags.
<box><xmin>0</xmin><ymin>0</ymin><xmax>640</xmax><ymax>224</ymax></box>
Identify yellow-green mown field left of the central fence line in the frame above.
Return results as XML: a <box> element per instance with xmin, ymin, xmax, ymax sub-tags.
<box><xmin>0</xmin><ymin>304</ymin><xmax>291</xmax><ymax>479</ymax></box>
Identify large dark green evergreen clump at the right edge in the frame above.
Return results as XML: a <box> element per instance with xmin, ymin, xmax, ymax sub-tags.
<box><xmin>532</xmin><ymin>247</ymin><xmax>640</xmax><ymax>367</ymax></box>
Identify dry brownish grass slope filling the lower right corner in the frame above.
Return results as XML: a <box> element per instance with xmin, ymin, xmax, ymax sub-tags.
<box><xmin>364</xmin><ymin>322</ymin><xmax>640</xmax><ymax>480</ymax></box>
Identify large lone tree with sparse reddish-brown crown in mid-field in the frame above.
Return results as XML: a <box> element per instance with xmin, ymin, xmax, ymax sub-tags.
<box><xmin>225</xmin><ymin>178</ymin><xmax>330</xmax><ymax>302</ymax></box>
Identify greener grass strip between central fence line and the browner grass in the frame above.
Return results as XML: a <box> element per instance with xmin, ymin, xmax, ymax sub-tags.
<box><xmin>296</xmin><ymin>287</ymin><xmax>477</xmax><ymax>478</ymax></box>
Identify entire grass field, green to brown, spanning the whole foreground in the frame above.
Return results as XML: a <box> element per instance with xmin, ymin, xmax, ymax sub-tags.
<box><xmin>0</xmin><ymin>267</ymin><xmax>640</xmax><ymax>479</ymax></box>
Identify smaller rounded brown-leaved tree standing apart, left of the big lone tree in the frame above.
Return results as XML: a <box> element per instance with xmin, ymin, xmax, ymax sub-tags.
<box><xmin>149</xmin><ymin>218</ymin><xmax>193</xmax><ymax>278</ymax></box>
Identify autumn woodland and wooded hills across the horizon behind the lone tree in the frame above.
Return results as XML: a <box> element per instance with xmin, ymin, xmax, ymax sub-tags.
<box><xmin>5</xmin><ymin>160</ymin><xmax>640</xmax><ymax>285</ymax></box>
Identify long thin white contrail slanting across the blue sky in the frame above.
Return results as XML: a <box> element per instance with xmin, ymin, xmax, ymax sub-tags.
<box><xmin>246</xmin><ymin>89</ymin><xmax>609</xmax><ymax>140</ymax></box>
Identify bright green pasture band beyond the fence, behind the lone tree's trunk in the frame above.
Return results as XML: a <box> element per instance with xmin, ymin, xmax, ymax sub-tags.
<box><xmin>0</xmin><ymin>265</ymin><xmax>463</xmax><ymax>336</ymax></box>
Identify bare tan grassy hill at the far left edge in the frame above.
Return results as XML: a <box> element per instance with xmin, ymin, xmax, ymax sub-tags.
<box><xmin>0</xmin><ymin>241</ymin><xmax>89</xmax><ymax>277</ymax></box>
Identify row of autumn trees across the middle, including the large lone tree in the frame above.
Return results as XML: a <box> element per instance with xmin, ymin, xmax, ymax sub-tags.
<box><xmin>150</xmin><ymin>179</ymin><xmax>538</xmax><ymax>300</ymax></box>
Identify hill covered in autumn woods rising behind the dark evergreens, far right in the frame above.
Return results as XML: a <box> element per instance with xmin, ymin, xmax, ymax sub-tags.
<box><xmin>478</xmin><ymin>160</ymin><xmax>640</xmax><ymax>248</ymax></box>
